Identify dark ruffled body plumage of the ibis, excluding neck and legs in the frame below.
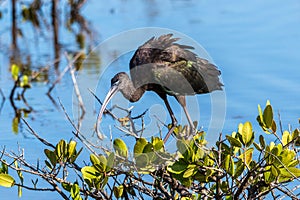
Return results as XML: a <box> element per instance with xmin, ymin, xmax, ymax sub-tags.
<box><xmin>130</xmin><ymin>34</ymin><xmax>223</xmax><ymax>95</ymax></box>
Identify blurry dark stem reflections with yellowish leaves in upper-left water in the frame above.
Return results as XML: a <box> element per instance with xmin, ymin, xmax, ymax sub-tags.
<box><xmin>1</xmin><ymin>0</ymin><xmax>99</xmax><ymax>139</ymax></box>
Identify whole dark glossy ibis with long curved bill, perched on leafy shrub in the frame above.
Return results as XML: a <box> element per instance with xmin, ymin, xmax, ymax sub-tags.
<box><xmin>96</xmin><ymin>34</ymin><xmax>223</xmax><ymax>142</ymax></box>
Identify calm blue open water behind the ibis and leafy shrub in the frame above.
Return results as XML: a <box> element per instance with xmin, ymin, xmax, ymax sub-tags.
<box><xmin>0</xmin><ymin>0</ymin><xmax>300</xmax><ymax>199</ymax></box>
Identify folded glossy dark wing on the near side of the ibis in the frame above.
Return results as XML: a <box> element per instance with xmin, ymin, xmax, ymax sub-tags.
<box><xmin>152</xmin><ymin>58</ymin><xmax>222</xmax><ymax>95</ymax></box>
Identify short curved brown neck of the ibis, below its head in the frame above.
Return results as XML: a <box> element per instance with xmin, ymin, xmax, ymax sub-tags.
<box><xmin>121</xmin><ymin>81</ymin><xmax>145</xmax><ymax>102</ymax></box>
